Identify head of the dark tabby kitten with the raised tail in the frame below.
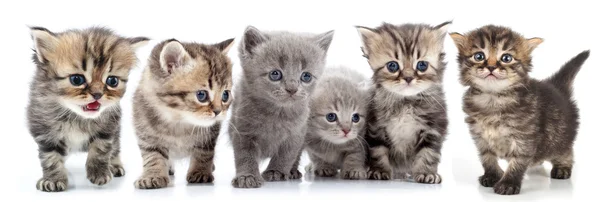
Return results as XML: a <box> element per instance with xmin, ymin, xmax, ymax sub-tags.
<box><xmin>450</xmin><ymin>25</ymin><xmax>543</xmax><ymax>92</ymax></box>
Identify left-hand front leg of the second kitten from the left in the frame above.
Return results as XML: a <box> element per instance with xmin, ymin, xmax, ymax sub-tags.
<box><xmin>134</xmin><ymin>145</ymin><xmax>170</xmax><ymax>189</ymax></box>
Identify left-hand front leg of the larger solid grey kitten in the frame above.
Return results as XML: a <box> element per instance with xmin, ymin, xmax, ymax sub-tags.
<box><xmin>230</xmin><ymin>134</ymin><xmax>264</xmax><ymax>188</ymax></box>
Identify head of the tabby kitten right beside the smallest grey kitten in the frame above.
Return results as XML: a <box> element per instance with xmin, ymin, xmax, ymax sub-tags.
<box><xmin>357</xmin><ymin>22</ymin><xmax>450</xmax><ymax>96</ymax></box>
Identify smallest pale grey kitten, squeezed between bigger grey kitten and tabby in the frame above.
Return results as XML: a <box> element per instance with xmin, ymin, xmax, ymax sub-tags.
<box><xmin>305</xmin><ymin>68</ymin><xmax>370</xmax><ymax>179</ymax></box>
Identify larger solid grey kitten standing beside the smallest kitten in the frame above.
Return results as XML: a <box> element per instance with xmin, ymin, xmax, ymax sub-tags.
<box><xmin>229</xmin><ymin>26</ymin><xmax>333</xmax><ymax>188</ymax></box>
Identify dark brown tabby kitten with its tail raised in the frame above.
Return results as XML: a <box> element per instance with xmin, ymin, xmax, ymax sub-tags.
<box><xmin>451</xmin><ymin>25</ymin><xmax>589</xmax><ymax>195</ymax></box>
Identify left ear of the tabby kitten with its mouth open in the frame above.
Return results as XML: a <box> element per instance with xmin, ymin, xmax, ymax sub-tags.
<box><xmin>30</xmin><ymin>27</ymin><xmax>58</xmax><ymax>64</ymax></box>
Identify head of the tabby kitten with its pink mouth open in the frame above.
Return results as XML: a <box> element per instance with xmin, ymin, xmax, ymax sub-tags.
<box><xmin>31</xmin><ymin>27</ymin><xmax>149</xmax><ymax>118</ymax></box>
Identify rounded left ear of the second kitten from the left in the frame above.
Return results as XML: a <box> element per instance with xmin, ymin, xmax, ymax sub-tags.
<box><xmin>160</xmin><ymin>40</ymin><xmax>191</xmax><ymax>74</ymax></box>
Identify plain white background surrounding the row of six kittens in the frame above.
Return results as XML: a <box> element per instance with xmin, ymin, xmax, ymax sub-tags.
<box><xmin>0</xmin><ymin>0</ymin><xmax>600</xmax><ymax>201</ymax></box>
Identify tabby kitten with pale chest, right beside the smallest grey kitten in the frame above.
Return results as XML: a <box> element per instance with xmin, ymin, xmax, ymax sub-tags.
<box><xmin>357</xmin><ymin>22</ymin><xmax>450</xmax><ymax>184</ymax></box>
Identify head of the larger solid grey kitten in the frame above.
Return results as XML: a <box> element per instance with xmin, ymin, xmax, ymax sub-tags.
<box><xmin>239</xmin><ymin>26</ymin><xmax>333</xmax><ymax>106</ymax></box>
